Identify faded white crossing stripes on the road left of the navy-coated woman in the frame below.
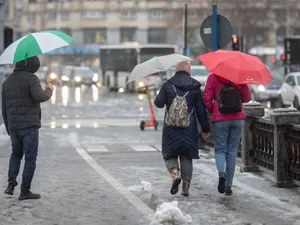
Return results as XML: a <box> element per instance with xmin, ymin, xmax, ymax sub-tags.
<box><xmin>82</xmin><ymin>143</ymin><xmax>161</xmax><ymax>154</ymax></box>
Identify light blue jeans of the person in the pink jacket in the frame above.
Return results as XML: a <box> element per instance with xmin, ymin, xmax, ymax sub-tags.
<box><xmin>213</xmin><ymin>120</ymin><xmax>244</xmax><ymax>187</ymax></box>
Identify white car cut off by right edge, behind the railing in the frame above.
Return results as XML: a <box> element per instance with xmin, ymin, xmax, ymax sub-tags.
<box><xmin>278</xmin><ymin>72</ymin><xmax>300</xmax><ymax>109</ymax></box>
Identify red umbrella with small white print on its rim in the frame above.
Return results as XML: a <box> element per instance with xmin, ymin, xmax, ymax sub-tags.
<box><xmin>198</xmin><ymin>50</ymin><xmax>273</xmax><ymax>84</ymax></box>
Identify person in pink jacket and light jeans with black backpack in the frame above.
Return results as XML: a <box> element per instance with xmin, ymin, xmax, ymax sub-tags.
<box><xmin>204</xmin><ymin>74</ymin><xmax>251</xmax><ymax>196</ymax></box>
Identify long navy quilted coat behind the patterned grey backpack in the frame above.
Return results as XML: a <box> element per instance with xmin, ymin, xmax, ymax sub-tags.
<box><xmin>154</xmin><ymin>71</ymin><xmax>209</xmax><ymax>159</ymax></box>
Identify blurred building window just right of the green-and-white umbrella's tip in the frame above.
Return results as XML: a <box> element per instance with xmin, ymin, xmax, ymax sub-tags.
<box><xmin>83</xmin><ymin>28</ymin><xmax>106</xmax><ymax>45</ymax></box>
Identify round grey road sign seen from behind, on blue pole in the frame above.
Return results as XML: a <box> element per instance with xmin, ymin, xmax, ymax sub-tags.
<box><xmin>200</xmin><ymin>15</ymin><xmax>232</xmax><ymax>48</ymax></box>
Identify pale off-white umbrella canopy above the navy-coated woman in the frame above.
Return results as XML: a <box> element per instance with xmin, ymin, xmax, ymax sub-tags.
<box><xmin>127</xmin><ymin>54</ymin><xmax>193</xmax><ymax>83</ymax></box>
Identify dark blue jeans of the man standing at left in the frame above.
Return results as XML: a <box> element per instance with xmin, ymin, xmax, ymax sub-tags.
<box><xmin>8</xmin><ymin>128</ymin><xmax>39</xmax><ymax>192</ymax></box>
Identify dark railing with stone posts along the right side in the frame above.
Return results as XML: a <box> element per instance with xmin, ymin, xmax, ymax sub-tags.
<box><xmin>201</xmin><ymin>102</ymin><xmax>300</xmax><ymax>187</ymax></box>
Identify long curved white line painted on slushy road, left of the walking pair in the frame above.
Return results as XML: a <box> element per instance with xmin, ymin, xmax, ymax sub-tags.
<box><xmin>68</xmin><ymin>133</ymin><xmax>154</xmax><ymax>218</ymax></box>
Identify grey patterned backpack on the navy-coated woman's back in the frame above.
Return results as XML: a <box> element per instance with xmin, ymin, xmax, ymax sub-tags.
<box><xmin>166</xmin><ymin>85</ymin><xmax>194</xmax><ymax>128</ymax></box>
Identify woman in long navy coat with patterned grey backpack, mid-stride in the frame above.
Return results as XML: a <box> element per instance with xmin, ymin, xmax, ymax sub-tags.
<box><xmin>154</xmin><ymin>62</ymin><xmax>210</xmax><ymax>196</ymax></box>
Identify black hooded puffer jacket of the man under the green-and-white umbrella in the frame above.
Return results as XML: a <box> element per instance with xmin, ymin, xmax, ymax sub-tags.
<box><xmin>2</xmin><ymin>56</ymin><xmax>52</xmax><ymax>133</ymax></box>
